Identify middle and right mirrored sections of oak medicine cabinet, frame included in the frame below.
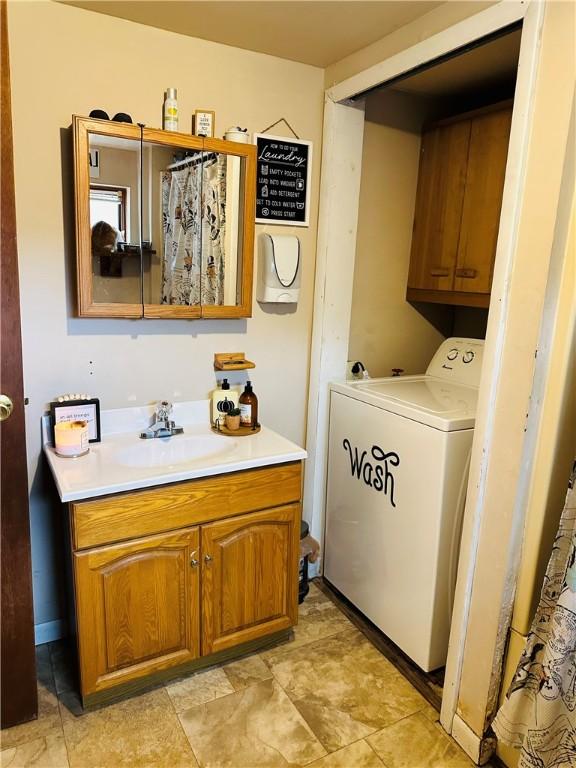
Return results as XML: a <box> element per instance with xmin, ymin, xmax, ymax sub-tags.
<box><xmin>142</xmin><ymin>128</ymin><xmax>256</xmax><ymax>318</ymax></box>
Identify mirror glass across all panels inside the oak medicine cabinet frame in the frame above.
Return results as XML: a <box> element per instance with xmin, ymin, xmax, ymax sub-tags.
<box><xmin>89</xmin><ymin>134</ymin><xmax>245</xmax><ymax>306</ymax></box>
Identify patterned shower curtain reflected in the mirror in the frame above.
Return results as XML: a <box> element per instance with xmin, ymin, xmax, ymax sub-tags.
<box><xmin>162</xmin><ymin>155</ymin><xmax>226</xmax><ymax>305</ymax></box>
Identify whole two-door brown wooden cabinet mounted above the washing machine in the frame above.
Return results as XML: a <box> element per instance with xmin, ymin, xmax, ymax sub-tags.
<box><xmin>407</xmin><ymin>102</ymin><xmax>512</xmax><ymax>307</ymax></box>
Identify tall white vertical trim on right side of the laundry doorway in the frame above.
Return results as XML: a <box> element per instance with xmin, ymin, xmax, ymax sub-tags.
<box><xmin>441</xmin><ymin>3</ymin><xmax>544</xmax><ymax>762</ymax></box>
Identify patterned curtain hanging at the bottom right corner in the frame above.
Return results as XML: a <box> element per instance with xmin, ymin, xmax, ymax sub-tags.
<box><xmin>492</xmin><ymin>462</ymin><xmax>576</xmax><ymax>768</ymax></box>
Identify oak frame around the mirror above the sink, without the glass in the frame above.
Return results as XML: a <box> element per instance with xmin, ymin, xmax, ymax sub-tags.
<box><xmin>73</xmin><ymin>115</ymin><xmax>256</xmax><ymax>319</ymax></box>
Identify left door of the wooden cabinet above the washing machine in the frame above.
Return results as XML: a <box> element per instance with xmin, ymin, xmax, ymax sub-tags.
<box><xmin>408</xmin><ymin>120</ymin><xmax>470</xmax><ymax>291</ymax></box>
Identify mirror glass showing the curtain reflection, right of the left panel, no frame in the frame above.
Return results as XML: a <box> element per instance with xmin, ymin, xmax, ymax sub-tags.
<box><xmin>142</xmin><ymin>143</ymin><xmax>243</xmax><ymax>306</ymax></box>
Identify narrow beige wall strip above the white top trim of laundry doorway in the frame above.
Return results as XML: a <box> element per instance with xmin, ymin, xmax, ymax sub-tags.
<box><xmin>325</xmin><ymin>0</ymin><xmax>495</xmax><ymax>88</ymax></box>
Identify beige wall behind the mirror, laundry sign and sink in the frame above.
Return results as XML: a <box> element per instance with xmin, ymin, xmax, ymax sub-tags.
<box><xmin>8</xmin><ymin>2</ymin><xmax>323</xmax><ymax>623</ymax></box>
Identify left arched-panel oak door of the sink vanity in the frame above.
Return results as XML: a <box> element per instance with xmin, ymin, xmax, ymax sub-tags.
<box><xmin>74</xmin><ymin>528</ymin><xmax>200</xmax><ymax>696</ymax></box>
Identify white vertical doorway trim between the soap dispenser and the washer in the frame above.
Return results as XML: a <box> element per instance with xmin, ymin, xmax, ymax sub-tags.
<box><xmin>303</xmin><ymin>95</ymin><xmax>364</xmax><ymax>541</ymax></box>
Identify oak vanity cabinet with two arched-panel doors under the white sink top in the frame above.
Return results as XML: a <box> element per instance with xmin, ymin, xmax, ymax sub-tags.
<box><xmin>69</xmin><ymin>462</ymin><xmax>301</xmax><ymax>705</ymax></box>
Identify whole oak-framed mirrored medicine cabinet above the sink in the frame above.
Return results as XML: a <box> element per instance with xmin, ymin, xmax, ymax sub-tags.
<box><xmin>74</xmin><ymin>117</ymin><xmax>256</xmax><ymax>319</ymax></box>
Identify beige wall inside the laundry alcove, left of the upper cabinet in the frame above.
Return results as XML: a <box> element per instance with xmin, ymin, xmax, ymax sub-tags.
<box><xmin>348</xmin><ymin>91</ymin><xmax>451</xmax><ymax>377</ymax></box>
